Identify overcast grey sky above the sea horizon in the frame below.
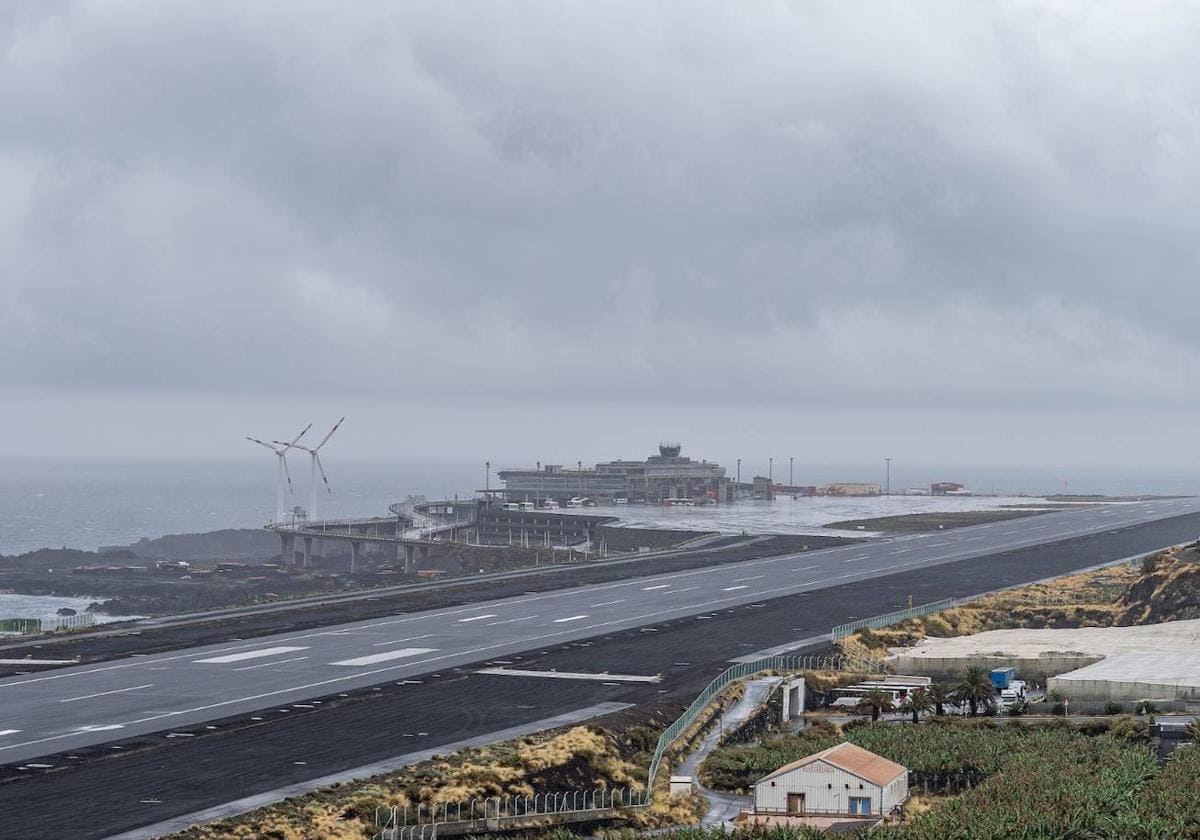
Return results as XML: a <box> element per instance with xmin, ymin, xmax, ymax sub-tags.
<box><xmin>0</xmin><ymin>0</ymin><xmax>1200</xmax><ymax>464</ymax></box>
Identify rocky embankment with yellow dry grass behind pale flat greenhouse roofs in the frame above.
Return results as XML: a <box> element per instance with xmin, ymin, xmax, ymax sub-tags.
<box><xmin>848</xmin><ymin>545</ymin><xmax>1200</xmax><ymax>653</ymax></box>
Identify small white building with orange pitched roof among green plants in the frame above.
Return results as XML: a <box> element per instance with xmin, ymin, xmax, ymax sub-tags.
<box><xmin>754</xmin><ymin>743</ymin><xmax>908</xmax><ymax>817</ymax></box>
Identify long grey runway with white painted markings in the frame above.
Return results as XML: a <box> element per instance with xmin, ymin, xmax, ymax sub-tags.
<box><xmin>0</xmin><ymin>499</ymin><xmax>1200</xmax><ymax>763</ymax></box>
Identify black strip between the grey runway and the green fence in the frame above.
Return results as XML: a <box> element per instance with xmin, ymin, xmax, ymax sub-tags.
<box><xmin>0</xmin><ymin>503</ymin><xmax>1200</xmax><ymax>838</ymax></box>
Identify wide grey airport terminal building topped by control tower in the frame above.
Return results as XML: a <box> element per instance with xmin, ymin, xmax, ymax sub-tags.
<box><xmin>499</xmin><ymin>444</ymin><xmax>734</xmax><ymax>504</ymax></box>
